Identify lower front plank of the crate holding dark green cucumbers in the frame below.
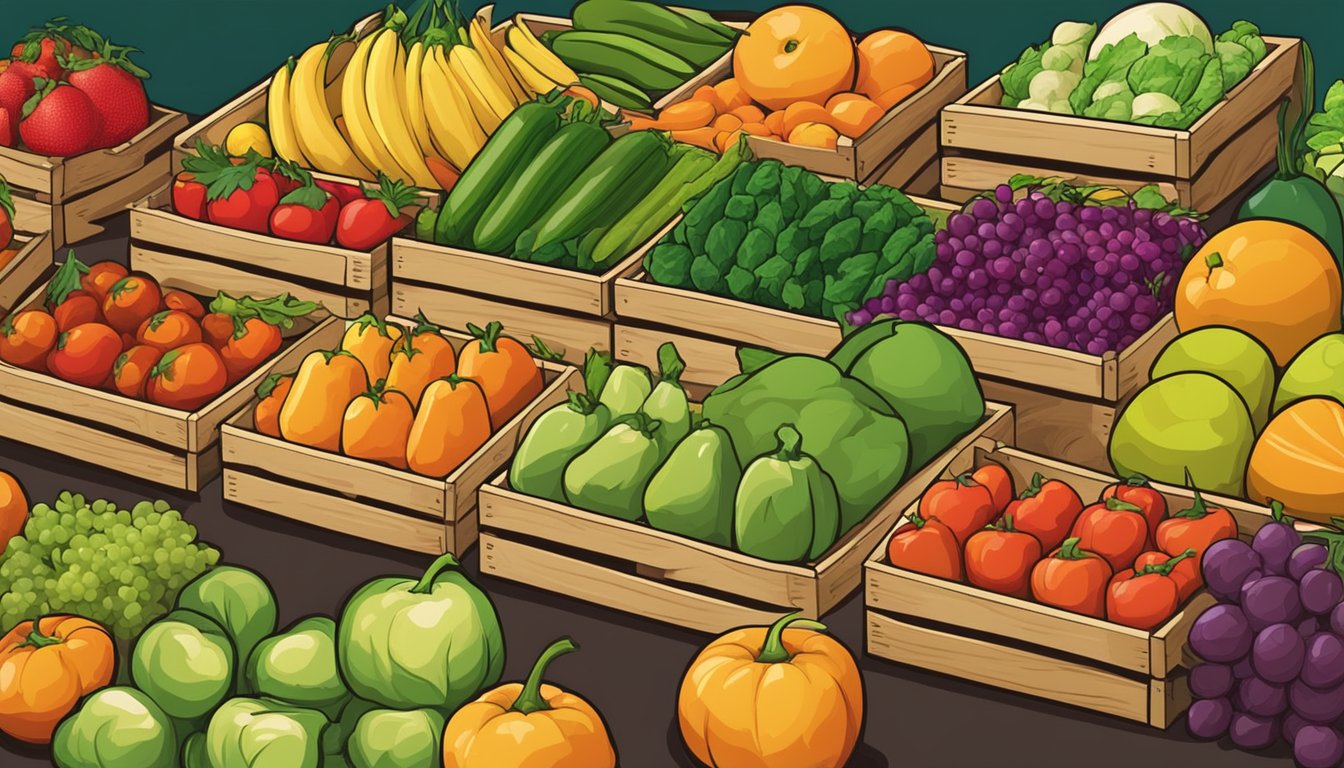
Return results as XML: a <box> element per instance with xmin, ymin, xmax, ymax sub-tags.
<box><xmin>391</xmin><ymin>278</ymin><xmax>612</xmax><ymax>364</ymax></box>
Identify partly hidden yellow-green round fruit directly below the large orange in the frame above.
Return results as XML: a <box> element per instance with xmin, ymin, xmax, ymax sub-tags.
<box><xmin>1150</xmin><ymin>325</ymin><xmax>1274</xmax><ymax>434</ymax></box>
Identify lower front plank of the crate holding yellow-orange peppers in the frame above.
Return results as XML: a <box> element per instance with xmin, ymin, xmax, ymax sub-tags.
<box><xmin>223</xmin><ymin>467</ymin><xmax>451</xmax><ymax>554</ymax></box>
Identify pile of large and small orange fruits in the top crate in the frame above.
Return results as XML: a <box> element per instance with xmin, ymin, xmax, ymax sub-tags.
<box><xmin>626</xmin><ymin>0</ymin><xmax>937</xmax><ymax>152</ymax></box>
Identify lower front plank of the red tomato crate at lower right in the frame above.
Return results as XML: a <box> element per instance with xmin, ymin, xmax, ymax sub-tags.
<box><xmin>866</xmin><ymin>612</ymin><xmax>1150</xmax><ymax>722</ymax></box>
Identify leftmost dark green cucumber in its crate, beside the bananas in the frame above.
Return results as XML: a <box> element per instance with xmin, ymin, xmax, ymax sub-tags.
<box><xmin>434</xmin><ymin>100</ymin><xmax>563</xmax><ymax>247</ymax></box>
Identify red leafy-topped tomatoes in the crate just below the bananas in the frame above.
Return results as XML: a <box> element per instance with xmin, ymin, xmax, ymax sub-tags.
<box><xmin>172</xmin><ymin>140</ymin><xmax>421</xmax><ymax>250</ymax></box>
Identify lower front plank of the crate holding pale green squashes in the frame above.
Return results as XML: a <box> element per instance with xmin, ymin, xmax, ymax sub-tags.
<box><xmin>481</xmin><ymin>530</ymin><xmax>780</xmax><ymax>633</ymax></box>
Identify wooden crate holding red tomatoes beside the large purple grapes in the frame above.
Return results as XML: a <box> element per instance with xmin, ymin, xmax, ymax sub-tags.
<box><xmin>864</xmin><ymin>443</ymin><xmax>1284</xmax><ymax>728</ymax></box>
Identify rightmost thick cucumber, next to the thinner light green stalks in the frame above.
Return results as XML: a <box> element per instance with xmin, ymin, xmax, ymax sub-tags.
<box><xmin>523</xmin><ymin>130</ymin><xmax>668</xmax><ymax>250</ymax></box>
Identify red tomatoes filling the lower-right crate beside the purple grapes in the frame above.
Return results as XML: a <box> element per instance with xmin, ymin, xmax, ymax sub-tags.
<box><xmin>887</xmin><ymin>463</ymin><xmax>1236</xmax><ymax>631</ymax></box>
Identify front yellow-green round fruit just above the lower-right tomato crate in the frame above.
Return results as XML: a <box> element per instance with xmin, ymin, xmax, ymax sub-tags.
<box><xmin>1110</xmin><ymin>373</ymin><xmax>1255</xmax><ymax>496</ymax></box>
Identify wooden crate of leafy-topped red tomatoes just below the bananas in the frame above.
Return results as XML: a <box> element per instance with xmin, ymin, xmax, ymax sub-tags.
<box><xmin>130</xmin><ymin>190</ymin><xmax>391</xmax><ymax>317</ymax></box>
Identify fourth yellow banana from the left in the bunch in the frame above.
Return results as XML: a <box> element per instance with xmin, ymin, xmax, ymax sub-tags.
<box><xmin>364</xmin><ymin>30</ymin><xmax>439</xmax><ymax>190</ymax></box>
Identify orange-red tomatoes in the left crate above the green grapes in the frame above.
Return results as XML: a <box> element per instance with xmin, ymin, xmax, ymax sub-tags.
<box><xmin>0</xmin><ymin>252</ymin><xmax>317</xmax><ymax>410</ymax></box>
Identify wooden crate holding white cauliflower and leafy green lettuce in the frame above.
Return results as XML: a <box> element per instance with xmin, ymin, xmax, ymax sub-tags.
<box><xmin>941</xmin><ymin>36</ymin><xmax>1301</xmax><ymax>211</ymax></box>
